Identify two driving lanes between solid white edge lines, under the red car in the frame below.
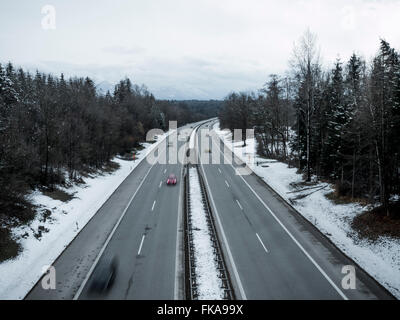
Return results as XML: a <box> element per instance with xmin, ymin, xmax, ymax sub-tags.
<box><xmin>79</xmin><ymin>135</ymin><xmax>182</xmax><ymax>300</ymax></box>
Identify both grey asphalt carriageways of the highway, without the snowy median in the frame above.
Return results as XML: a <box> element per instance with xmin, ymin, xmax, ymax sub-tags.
<box><xmin>26</xmin><ymin>122</ymin><xmax>392</xmax><ymax>300</ymax></box>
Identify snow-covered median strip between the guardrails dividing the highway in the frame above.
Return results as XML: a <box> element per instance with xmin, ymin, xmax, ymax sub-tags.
<box><xmin>189</xmin><ymin>168</ymin><xmax>224</xmax><ymax>300</ymax></box>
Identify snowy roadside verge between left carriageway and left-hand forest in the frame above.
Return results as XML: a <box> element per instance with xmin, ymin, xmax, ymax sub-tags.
<box><xmin>0</xmin><ymin>133</ymin><xmax>169</xmax><ymax>299</ymax></box>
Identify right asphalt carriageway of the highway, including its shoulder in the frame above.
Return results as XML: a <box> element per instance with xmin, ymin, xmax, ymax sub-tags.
<box><xmin>197</xmin><ymin>125</ymin><xmax>392</xmax><ymax>300</ymax></box>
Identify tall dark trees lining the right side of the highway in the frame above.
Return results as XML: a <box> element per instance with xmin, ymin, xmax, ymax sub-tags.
<box><xmin>219</xmin><ymin>31</ymin><xmax>400</xmax><ymax>215</ymax></box>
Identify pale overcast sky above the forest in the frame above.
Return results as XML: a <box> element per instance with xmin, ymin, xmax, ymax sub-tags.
<box><xmin>0</xmin><ymin>0</ymin><xmax>400</xmax><ymax>99</ymax></box>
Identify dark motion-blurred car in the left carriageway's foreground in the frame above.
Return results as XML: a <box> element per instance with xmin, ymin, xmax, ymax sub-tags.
<box><xmin>90</xmin><ymin>256</ymin><xmax>118</xmax><ymax>293</ymax></box>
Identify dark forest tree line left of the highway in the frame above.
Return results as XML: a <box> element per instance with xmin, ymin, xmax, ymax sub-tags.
<box><xmin>0</xmin><ymin>63</ymin><xmax>216</xmax><ymax>221</ymax></box>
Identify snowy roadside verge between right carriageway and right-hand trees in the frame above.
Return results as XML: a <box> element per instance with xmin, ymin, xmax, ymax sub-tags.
<box><xmin>213</xmin><ymin>123</ymin><xmax>400</xmax><ymax>298</ymax></box>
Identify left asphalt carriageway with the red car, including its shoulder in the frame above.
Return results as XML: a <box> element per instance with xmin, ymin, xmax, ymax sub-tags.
<box><xmin>26</xmin><ymin>126</ymin><xmax>195</xmax><ymax>300</ymax></box>
